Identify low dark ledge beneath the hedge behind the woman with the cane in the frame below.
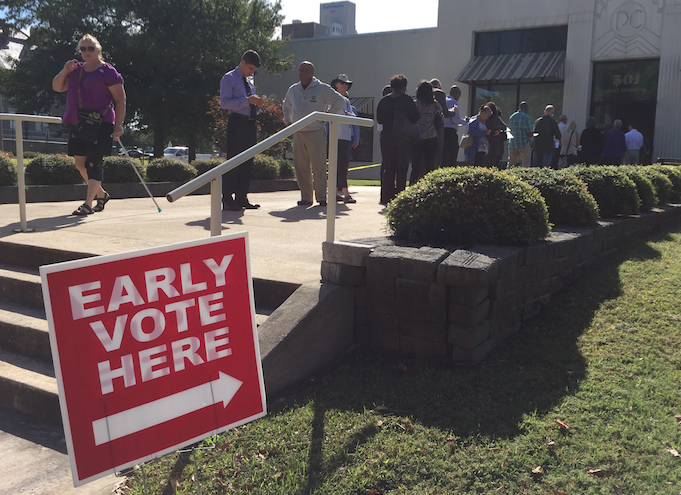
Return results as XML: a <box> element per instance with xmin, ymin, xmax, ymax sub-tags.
<box><xmin>0</xmin><ymin>179</ymin><xmax>298</xmax><ymax>204</ymax></box>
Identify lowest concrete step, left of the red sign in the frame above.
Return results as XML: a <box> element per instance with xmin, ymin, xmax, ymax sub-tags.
<box><xmin>0</xmin><ymin>349</ymin><xmax>61</xmax><ymax>424</ymax></box>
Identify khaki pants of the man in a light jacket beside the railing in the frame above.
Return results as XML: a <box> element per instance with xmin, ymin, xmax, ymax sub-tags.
<box><xmin>293</xmin><ymin>129</ymin><xmax>326</xmax><ymax>203</ymax></box>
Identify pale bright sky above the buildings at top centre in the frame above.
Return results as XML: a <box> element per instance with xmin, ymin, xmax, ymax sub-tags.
<box><xmin>281</xmin><ymin>0</ymin><xmax>438</xmax><ymax>33</ymax></box>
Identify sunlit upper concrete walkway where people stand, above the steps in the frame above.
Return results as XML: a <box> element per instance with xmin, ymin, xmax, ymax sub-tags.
<box><xmin>0</xmin><ymin>186</ymin><xmax>386</xmax><ymax>283</ymax></box>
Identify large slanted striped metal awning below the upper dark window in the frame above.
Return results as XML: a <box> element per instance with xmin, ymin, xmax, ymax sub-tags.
<box><xmin>456</xmin><ymin>52</ymin><xmax>565</xmax><ymax>84</ymax></box>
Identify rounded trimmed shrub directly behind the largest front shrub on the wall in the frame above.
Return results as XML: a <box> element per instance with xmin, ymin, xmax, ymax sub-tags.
<box><xmin>509</xmin><ymin>168</ymin><xmax>596</xmax><ymax>225</ymax></box>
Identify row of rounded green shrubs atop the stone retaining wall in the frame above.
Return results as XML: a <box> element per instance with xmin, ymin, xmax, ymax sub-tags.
<box><xmin>387</xmin><ymin>165</ymin><xmax>681</xmax><ymax>245</ymax></box>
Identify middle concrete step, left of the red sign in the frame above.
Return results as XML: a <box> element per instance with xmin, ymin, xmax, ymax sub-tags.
<box><xmin>0</xmin><ymin>300</ymin><xmax>52</xmax><ymax>363</ymax></box>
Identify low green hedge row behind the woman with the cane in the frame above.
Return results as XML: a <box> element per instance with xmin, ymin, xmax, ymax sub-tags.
<box><xmin>0</xmin><ymin>154</ymin><xmax>295</xmax><ymax>186</ymax></box>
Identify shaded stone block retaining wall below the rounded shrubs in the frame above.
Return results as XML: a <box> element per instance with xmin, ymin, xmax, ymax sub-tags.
<box><xmin>321</xmin><ymin>205</ymin><xmax>681</xmax><ymax>363</ymax></box>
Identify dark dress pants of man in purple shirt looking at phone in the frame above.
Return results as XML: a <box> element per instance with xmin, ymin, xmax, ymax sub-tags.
<box><xmin>222</xmin><ymin>113</ymin><xmax>257</xmax><ymax>208</ymax></box>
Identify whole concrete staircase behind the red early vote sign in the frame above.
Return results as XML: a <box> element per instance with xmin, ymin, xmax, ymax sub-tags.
<box><xmin>0</xmin><ymin>241</ymin><xmax>299</xmax><ymax>425</ymax></box>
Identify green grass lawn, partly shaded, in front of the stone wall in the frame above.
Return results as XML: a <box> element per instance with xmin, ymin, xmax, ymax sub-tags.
<box><xmin>121</xmin><ymin>231</ymin><xmax>681</xmax><ymax>495</ymax></box>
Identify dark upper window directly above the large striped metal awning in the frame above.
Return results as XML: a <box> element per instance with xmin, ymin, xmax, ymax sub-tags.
<box><xmin>475</xmin><ymin>26</ymin><xmax>567</xmax><ymax>56</ymax></box>
